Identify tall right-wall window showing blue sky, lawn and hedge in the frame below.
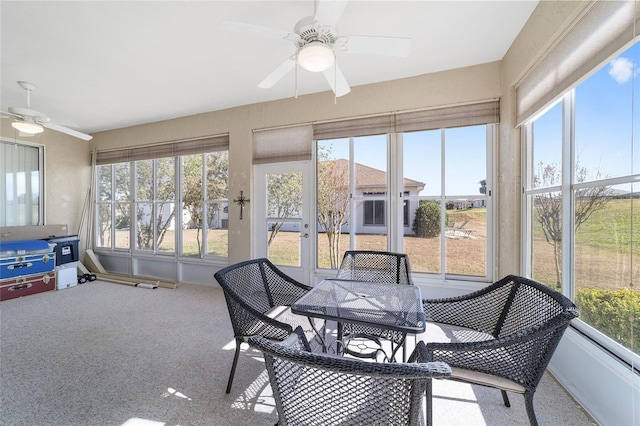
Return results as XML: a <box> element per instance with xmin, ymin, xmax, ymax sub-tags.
<box><xmin>524</xmin><ymin>40</ymin><xmax>640</xmax><ymax>356</ymax></box>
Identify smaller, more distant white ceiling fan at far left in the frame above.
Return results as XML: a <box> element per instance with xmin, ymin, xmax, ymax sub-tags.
<box><xmin>0</xmin><ymin>81</ymin><xmax>93</xmax><ymax>141</ymax></box>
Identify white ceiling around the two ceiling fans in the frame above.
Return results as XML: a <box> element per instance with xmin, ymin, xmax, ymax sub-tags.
<box><xmin>0</xmin><ymin>0</ymin><xmax>538</xmax><ymax>133</ymax></box>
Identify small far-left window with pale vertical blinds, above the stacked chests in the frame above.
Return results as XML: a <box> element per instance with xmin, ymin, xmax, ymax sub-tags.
<box><xmin>0</xmin><ymin>140</ymin><xmax>44</xmax><ymax>226</ymax></box>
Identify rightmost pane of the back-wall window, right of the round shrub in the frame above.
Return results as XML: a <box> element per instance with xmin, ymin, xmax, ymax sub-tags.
<box><xmin>444</xmin><ymin>126</ymin><xmax>487</xmax><ymax>277</ymax></box>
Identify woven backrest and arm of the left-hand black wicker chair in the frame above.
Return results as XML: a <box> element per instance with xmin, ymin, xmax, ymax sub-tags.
<box><xmin>214</xmin><ymin>258</ymin><xmax>311</xmax><ymax>338</ymax></box>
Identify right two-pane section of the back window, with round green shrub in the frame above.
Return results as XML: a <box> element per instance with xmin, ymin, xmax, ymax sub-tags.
<box><xmin>403</xmin><ymin>125</ymin><xmax>493</xmax><ymax>277</ymax></box>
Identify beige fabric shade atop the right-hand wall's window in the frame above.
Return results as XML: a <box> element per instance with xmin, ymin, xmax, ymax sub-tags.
<box><xmin>516</xmin><ymin>0</ymin><xmax>640</xmax><ymax>125</ymax></box>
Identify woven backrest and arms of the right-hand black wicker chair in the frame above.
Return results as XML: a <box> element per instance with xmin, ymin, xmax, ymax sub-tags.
<box><xmin>423</xmin><ymin>275</ymin><xmax>579</xmax><ymax>390</ymax></box>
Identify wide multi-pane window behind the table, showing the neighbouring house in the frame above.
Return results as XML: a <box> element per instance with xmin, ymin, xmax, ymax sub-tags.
<box><xmin>316</xmin><ymin>114</ymin><xmax>495</xmax><ymax>281</ymax></box>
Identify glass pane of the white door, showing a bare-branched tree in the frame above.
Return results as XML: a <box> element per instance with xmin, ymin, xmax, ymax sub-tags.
<box><xmin>267</xmin><ymin>172</ymin><xmax>302</xmax><ymax>266</ymax></box>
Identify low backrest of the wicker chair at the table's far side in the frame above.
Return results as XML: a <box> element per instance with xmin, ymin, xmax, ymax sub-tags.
<box><xmin>336</xmin><ymin>250</ymin><xmax>413</xmax><ymax>284</ymax></box>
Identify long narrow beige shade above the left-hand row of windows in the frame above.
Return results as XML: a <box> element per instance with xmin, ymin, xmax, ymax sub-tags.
<box><xmin>96</xmin><ymin>134</ymin><xmax>229</xmax><ymax>165</ymax></box>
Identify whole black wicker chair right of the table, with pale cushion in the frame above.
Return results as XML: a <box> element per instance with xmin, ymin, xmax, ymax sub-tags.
<box><xmin>419</xmin><ymin>275</ymin><xmax>579</xmax><ymax>425</ymax></box>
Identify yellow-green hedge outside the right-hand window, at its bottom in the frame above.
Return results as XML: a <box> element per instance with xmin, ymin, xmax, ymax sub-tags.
<box><xmin>575</xmin><ymin>288</ymin><xmax>640</xmax><ymax>354</ymax></box>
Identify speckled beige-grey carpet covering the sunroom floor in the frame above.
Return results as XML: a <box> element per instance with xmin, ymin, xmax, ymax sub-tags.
<box><xmin>0</xmin><ymin>281</ymin><xmax>594</xmax><ymax>426</ymax></box>
